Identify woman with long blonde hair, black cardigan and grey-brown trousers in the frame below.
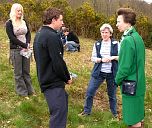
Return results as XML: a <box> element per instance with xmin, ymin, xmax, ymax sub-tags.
<box><xmin>6</xmin><ymin>3</ymin><xmax>34</xmax><ymax>99</ymax></box>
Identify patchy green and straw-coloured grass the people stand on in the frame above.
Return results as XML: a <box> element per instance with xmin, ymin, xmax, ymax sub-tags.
<box><xmin>0</xmin><ymin>26</ymin><xmax>152</xmax><ymax>128</ymax></box>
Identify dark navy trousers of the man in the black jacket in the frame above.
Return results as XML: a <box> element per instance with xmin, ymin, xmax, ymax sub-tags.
<box><xmin>44</xmin><ymin>88</ymin><xmax>68</xmax><ymax>128</ymax></box>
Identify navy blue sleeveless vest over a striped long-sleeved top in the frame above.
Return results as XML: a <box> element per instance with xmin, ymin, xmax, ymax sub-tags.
<box><xmin>92</xmin><ymin>39</ymin><xmax>118</xmax><ymax>78</ymax></box>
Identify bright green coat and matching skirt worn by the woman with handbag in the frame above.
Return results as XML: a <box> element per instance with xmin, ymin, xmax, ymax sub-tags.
<box><xmin>115</xmin><ymin>27</ymin><xmax>145</xmax><ymax>125</ymax></box>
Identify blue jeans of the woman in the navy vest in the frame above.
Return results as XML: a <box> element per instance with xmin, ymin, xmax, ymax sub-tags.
<box><xmin>84</xmin><ymin>72</ymin><xmax>117</xmax><ymax>116</ymax></box>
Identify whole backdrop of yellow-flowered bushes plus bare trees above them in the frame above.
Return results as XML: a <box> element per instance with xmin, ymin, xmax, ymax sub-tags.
<box><xmin>0</xmin><ymin>0</ymin><xmax>152</xmax><ymax>48</ymax></box>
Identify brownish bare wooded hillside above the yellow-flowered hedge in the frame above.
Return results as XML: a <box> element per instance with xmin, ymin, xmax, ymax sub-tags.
<box><xmin>68</xmin><ymin>0</ymin><xmax>152</xmax><ymax>20</ymax></box>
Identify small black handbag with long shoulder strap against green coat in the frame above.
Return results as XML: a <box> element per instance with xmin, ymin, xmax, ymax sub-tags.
<box><xmin>122</xmin><ymin>36</ymin><xmax>138</xmax><ymax>96</ymax></box>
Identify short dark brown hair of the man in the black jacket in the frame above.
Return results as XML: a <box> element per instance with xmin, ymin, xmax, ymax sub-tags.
<box><xmin>43</xmin><ymin>8</ymin><xmax>63</xmax><ymax>25</ymax></box>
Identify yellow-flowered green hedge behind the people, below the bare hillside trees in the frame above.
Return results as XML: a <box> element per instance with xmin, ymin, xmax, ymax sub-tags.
<box><xmin>0</xmin><ymin>0</ymin><xmax>152</xmax><ymax>48</ymax></box>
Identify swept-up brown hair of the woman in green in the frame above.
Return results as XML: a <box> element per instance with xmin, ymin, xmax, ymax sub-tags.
<box><xmin>117</xmin><ymin>8</ymin><xmax>136</xmax><ymax>25</ymax></box>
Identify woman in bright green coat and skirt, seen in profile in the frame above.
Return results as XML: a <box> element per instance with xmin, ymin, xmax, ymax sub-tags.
<box><xmin>115</xmin><ymin>8</ymin><xmax>146</xmax><ymax>128</ymax></box>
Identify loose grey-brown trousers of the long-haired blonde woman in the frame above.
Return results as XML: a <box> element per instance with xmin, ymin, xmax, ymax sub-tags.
<box><xmin>10</xmin><ymin>49</ymin><xmax>35</xmax><ymax>96</ymax></box>
